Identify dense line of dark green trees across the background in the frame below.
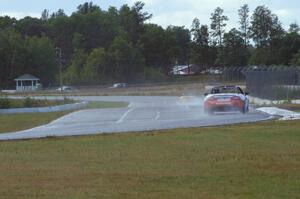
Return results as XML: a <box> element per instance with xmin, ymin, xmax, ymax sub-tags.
<box><xmin>0</xmin><ymin>2</ymin><xmax>300</xmax><ymax>88</ymax></box>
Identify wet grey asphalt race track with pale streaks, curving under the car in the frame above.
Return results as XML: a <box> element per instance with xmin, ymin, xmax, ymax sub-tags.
<box><xmin>0</xmin><ymin>96</ymin><xmax>270</xmax><ymax>140</ymax></box>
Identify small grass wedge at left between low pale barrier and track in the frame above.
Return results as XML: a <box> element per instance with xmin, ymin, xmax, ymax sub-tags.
<box><xmin>0</xmin><ymin>111</ymin><xmax>71</xmax><ymax>133</ymax></box>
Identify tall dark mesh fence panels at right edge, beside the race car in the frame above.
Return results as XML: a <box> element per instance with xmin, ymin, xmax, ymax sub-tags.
<box><xmin>243</xmin><ymin>66</ymin><xmax>300</xmax><ymax>100</ymax></box>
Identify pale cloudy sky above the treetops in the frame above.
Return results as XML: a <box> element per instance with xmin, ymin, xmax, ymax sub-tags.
<box><xmin>0</xmin><ymin>0</ymin><xmax>300</xmax><ymax>29</ymax></box>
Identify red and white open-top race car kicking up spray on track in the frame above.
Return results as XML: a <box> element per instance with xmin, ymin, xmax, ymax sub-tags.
<box><xmin>204</xmin><ymin>86</ymin><xmax>249</xmax><ymax>114</ymax></box>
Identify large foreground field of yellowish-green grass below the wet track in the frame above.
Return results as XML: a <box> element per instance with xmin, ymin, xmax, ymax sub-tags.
<box><xmin>0</xmin><ymin>121</ymin><xmax>300</xmax><ymax>199</ymax></box>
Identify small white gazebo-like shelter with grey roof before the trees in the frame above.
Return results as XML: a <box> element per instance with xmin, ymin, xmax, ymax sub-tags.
<box><xmin>15</xmin><ymin>74</ymin><xmax>40</xmax><ymax>92</ymax></box>
